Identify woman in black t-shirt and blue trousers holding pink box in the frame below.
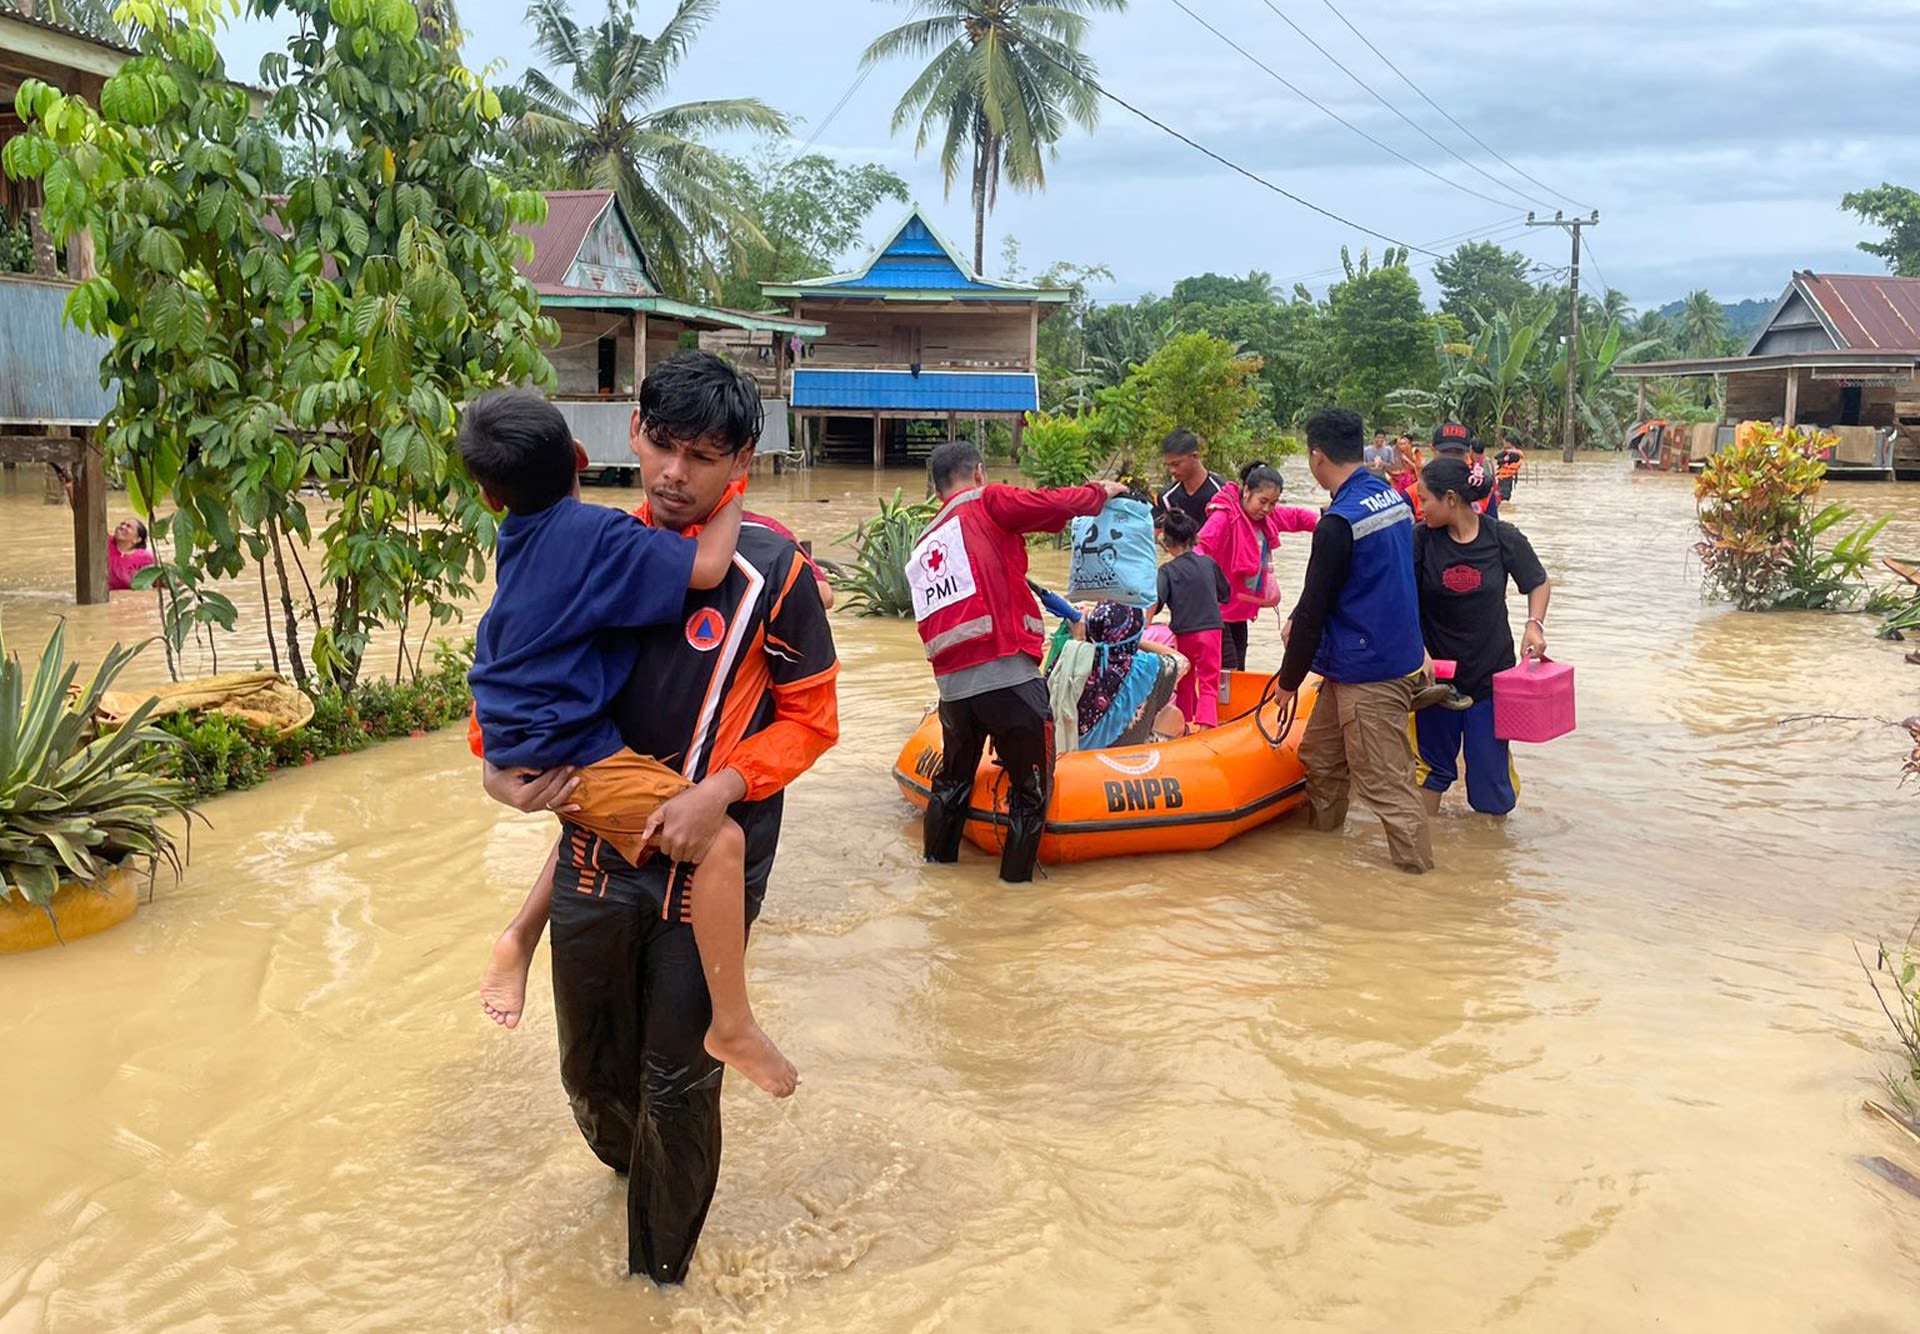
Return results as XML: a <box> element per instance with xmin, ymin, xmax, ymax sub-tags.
<box><xmin>1413</xmin><ymin>457</ymin><xmax>1551</xmax><ymax>816</ymax></box>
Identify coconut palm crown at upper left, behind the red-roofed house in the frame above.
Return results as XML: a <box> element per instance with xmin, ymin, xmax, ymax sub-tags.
<box><xmin>515</xmin><ymin>0</ymin><xmax>787</xmax><ymax>292</ymax></box>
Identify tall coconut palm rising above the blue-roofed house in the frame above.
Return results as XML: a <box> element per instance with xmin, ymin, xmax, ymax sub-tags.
<box><xmin>860</xmin><ymin>0</ymin><xmax>1127</xmax><ymax>273</ymax></box>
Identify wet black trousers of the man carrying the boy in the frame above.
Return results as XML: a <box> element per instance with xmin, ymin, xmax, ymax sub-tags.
<box><xmin>549</xmin><ymin>837</ymin><xmax>737</xmax><ymax>1282</ymax></box>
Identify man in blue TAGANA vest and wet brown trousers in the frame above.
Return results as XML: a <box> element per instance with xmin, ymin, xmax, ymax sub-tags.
<box><xmin>1277</xmin><ymin>407</ymin><xmax>1434</xmax><ymax>871</ymax></box>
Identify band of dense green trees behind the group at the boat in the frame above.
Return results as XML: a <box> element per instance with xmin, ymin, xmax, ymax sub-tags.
<box><xmin>1041</xmin><ymin>242</ymin><xmax>1651</xmax><ymax>454</ymax></box>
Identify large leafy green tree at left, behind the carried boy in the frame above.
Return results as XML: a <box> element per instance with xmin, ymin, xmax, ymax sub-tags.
<box><xmin>6</xmin><ymin>0</ymin><xmax>555</xmax><ymax>687</ymax></box>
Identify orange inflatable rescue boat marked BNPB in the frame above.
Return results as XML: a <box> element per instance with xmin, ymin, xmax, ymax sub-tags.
<box><xmin>893</xmin><ymin>672</ymin><xmax>1315</xmax><ymax>866</ymax></box>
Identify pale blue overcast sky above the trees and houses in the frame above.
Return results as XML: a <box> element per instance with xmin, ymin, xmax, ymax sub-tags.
<box><xmin>227</xmin><ymin>0</ymin><xmax>1920</xmax><ymax>307</ymax></box>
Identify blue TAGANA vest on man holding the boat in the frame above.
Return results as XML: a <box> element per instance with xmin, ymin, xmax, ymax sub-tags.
<box><xmin>1313</xmin><ymin>468</ymin><xmax>1427</xmax><ymax>685</ymax></box>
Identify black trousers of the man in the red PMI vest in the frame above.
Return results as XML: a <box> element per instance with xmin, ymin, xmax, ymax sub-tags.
<box><xmin>925</xmin><ymin>681</ymin><xmax>1054</xmax><ymax>885</ymax></box>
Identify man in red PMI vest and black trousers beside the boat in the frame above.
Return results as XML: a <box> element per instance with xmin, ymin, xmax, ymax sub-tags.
<box><xmin>906</xmin><ymin>440</ymin><xmax>1127</xmax><ymax>883</ymax></box>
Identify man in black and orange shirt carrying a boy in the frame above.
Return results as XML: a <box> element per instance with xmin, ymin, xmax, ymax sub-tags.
<box><xmin>486</xmin><ymin>351</ymin><xmax>839</xmax><ymax>1284</ymax></box>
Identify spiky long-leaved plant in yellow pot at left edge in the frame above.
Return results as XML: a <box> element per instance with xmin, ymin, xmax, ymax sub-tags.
<box><xmin>0</xmin><ymin>622</ymin><xmax>186</xmax><ymax>908</ymax></box>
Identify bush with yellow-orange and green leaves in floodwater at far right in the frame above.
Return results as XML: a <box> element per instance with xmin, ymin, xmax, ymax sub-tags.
<box><xmin>1693</xmin><ymin>422</ymin><xmax>1885</xmax><ymax>610</ymax></box>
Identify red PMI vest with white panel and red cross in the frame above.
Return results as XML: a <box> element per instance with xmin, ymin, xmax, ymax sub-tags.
<box><xmin>906</xmin><ymin>489</ymin><xmax>1046</xmax><ymax>676</ymax></box>
